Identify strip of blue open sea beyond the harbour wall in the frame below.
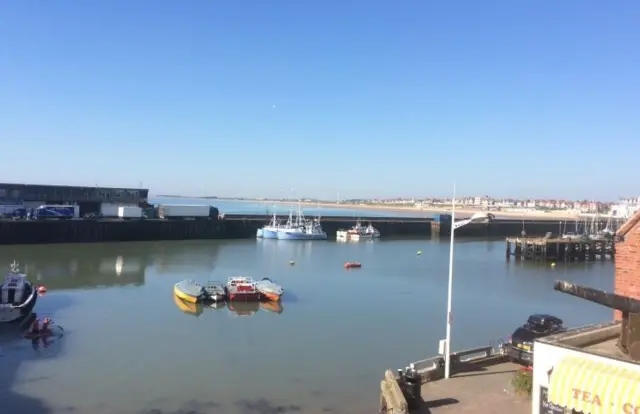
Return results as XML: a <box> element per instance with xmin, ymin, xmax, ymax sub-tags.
<box><xmin>149</xmin><ymin>198</ymin><xmax>433</xmax><ymax>218</ymax></box>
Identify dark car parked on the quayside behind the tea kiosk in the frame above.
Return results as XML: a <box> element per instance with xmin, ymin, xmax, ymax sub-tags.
<box><xmin>506</xmin><ymin>314</ymin><xmax>566</xmax><ymax>365</ymax></box>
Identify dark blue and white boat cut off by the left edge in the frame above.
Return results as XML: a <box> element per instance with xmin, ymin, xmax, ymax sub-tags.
<box><xmin>0</xmin><ymin>262</ymin><xmax>38</xmax><ymax>323</ymax></box>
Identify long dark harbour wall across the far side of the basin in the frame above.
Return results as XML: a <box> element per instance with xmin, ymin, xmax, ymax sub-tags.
<box><xmin>0</xmin><ymin>214</ymin><xmax>604</xmax><ymax>245</ymax></box>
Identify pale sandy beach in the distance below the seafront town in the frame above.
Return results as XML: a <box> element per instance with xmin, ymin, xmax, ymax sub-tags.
<box><xmin>264</xmin><ymin>200</ymin><xmax>580</xmax><ymax>220</ymax></box>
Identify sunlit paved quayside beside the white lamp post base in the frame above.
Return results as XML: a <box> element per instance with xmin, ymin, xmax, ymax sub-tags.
<box><xmin>418</xmin><ymin>363</ymin><xmax>531</xmax><ymax>414</ymax></box>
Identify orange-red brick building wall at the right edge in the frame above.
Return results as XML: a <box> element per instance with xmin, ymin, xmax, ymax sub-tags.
<box><xmin>615</xmin><ymin>211</ymin><xmax>640</xmax><ymax>320</ymax></box>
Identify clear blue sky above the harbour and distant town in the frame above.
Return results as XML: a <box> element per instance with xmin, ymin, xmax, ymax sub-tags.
<box><xmin>0</xmin><ymin>0</ymin><xmax>640</xmax><ymax>199</ymax></box>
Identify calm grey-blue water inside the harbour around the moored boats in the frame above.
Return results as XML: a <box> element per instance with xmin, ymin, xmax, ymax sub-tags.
<box><xmin>0</xmin><ymin>240</ymin><xmax>613</xmax><ymax>414</ymax></box>
